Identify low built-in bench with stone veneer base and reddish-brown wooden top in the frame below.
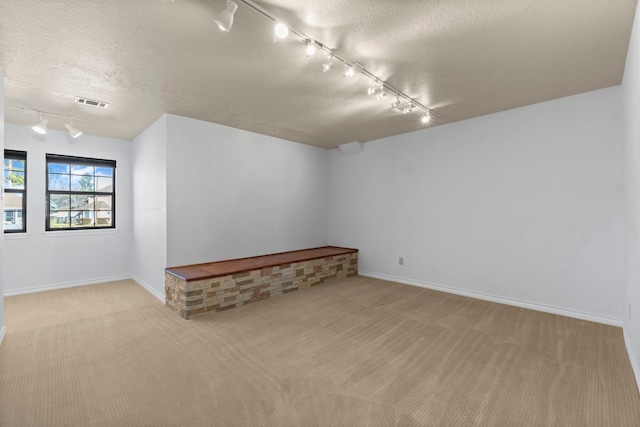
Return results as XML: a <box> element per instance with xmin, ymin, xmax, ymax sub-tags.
<box><xmin>165</xmin><ymin>246</ymin><xmax>358</xmax><ymax>319</ymax></box>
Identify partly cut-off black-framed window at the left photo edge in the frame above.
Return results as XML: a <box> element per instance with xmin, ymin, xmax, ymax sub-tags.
<box><xmin>3</xmin><ymin>150</ymin><xmax>27</xmax><ymax>233</ymax></box>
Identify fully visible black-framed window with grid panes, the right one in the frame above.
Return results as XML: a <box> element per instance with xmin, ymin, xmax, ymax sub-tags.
<box><xmin>45</xmin><ymin>154</ymin><xmax>116</xmax><ymax>231</ymax></box>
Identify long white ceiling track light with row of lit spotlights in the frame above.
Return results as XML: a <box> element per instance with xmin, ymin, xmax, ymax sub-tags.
<box><xmin>216</xmin><ymin>0</ymin><xmax>445</xmax><ymax>127</ymax></box>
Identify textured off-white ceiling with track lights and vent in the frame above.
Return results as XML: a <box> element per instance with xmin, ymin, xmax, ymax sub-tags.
<box><xmin>0</xmin><ymin>0</ymin><xmax>636</xmax><ymax>148</ymax></box>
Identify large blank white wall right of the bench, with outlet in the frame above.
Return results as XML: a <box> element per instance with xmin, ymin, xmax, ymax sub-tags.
<box><xmin>329</xmin><ymin>87</ymin><xmax>623</xmax><ymax>324</ymax></box>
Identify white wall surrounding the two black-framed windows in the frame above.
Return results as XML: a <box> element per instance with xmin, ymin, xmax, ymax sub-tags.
<box><xmin>3</xmin><ymin>123</ymin><xmax>132</xmax><ymax>295</ymax></box>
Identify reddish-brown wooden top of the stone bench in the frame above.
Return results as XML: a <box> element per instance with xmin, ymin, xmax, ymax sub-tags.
<box><xmin>165</xmin><ymin>246</ymin><xmax>358</xmax><ymax>282</ymax></box>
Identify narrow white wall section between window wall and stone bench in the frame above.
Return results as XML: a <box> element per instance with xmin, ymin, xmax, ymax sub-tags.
<box><xmin>131</xmin><ymin>115</ymin><xmax>167</xmax><ymax>301</ymax></box>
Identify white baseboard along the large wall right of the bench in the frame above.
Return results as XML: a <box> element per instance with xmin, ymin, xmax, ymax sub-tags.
<box><xmin>358</xmin><ymin>271</ymin><xmax>622</xmax><ymax>327</ymax></box>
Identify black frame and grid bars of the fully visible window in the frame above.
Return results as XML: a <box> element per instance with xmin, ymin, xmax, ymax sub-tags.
<box><xmin>45</xmin><ymin>153</ymin><xmax>116</xmax><ymax>232</ymax></box>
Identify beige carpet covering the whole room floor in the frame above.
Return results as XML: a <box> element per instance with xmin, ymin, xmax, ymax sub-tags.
<box><xmin>0</xmin><ymin>277</ymin><xmax>640</xmax><ymax>427</ymax></box>
